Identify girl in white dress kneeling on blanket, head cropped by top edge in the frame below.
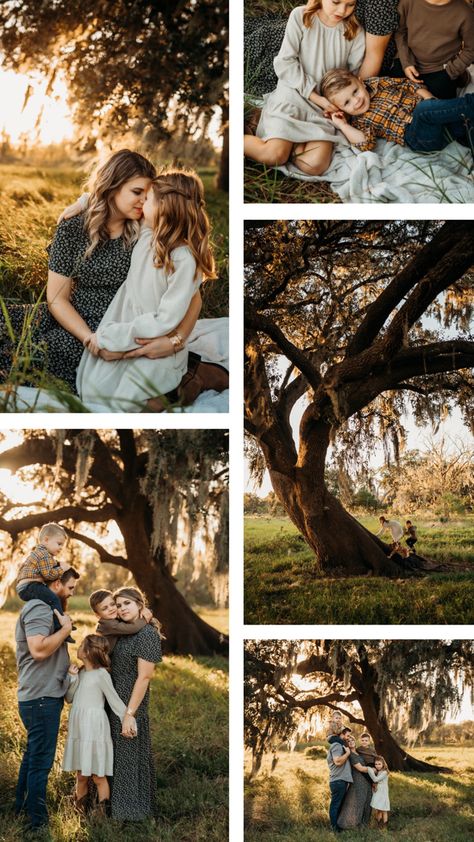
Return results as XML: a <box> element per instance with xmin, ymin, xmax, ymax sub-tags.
<box><xmin>244</xmin><ymin>0</ymin><xmax>365</xmax><ymax>175</ymax></box>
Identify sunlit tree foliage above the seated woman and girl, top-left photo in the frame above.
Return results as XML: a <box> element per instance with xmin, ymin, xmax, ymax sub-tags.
<box><xmin>0</xmin><ymin>0</ymin><xmax>228</xmax><ymax>184</ymax></box>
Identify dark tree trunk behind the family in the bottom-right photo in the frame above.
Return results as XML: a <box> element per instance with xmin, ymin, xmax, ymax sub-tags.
<box><xmin>358</xmin><ymin>689</ymin><xmax>451</xmax><ymax>772</ymax></box>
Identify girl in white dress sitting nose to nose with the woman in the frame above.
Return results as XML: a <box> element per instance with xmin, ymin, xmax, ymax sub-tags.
<box><xmin>77</xmin><ymin>170</ymin><xmax>216</xmax><ymax>412</ymax></box>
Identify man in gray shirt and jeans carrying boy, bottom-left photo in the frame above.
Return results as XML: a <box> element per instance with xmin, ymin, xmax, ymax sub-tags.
<box><xmin>15</xmin><ymin>567</ymin><xmax>79</xmax><ymax>830</ymax></box>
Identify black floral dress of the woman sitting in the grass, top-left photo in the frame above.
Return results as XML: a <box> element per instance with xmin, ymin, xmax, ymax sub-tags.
<box><xmin>0</xmin><ymin>214</ymin><xmax>132</xmax><ymax>393</ymax></box>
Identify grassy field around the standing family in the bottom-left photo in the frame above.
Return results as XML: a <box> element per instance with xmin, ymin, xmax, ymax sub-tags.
<box><xmin>0</xmin><ymin>597</ymin><xmax>228</xmax><ymax>842</ymax></box>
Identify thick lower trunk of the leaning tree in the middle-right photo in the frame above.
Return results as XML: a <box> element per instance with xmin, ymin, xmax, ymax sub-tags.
<box><xmin>270</xmin><ymin>469</ymin><xmax>407</xmax><ymax>577</ymax></box>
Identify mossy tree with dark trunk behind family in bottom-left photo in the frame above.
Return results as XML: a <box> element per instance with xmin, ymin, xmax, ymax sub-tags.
<box><xmin>0</xmin><ymin>430</ymin><xmax>228</xmax><ymax>654</ymax></box>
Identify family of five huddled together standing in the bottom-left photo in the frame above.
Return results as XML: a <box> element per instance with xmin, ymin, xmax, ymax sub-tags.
<box><xmin>15</xmin><ymin>523</ymin><xmax>161</xmax><ymax>830</ymax></box>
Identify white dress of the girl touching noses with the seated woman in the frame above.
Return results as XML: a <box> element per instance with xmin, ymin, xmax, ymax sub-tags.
<box><xmin>76</xmin><ymin>226</ymin><xmax>199</xmax><ymax>412</ymax></box>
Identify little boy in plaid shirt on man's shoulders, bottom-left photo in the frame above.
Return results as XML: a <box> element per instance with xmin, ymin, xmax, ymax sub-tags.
<box><xmin>16</xmin><ymin>523</ymin><xmax>75</xmax><ymax>643</ymax></box>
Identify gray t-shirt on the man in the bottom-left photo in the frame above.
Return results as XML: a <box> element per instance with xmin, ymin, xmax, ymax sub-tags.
<box><xmin>15</xmin><ymin>599</ymin><xmax>70</xmax><ymax>702</ymax></box>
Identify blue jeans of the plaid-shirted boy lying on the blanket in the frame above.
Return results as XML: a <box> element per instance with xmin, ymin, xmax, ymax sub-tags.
<box><xmin>405</xmin><ymin>94</ymin><xmax>474</xmax><ymax>152</ymax></box>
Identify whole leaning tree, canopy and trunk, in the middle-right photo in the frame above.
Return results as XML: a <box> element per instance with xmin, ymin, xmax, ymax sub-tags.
<box><xmin>245</xmin><ymin>220</ymin><xmax>474</xmax><ymax>574</ymax></box>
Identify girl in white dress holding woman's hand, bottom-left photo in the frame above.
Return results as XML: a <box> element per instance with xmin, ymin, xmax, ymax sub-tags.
<box><xmin>63</xmin><ymin>634</ymin><xmax>136</xmax><ymax>815</ymax></box>
